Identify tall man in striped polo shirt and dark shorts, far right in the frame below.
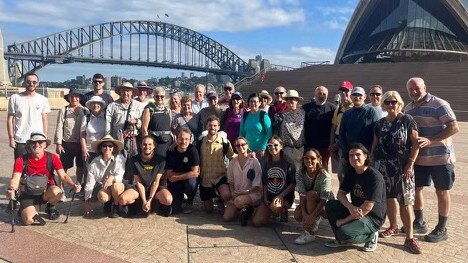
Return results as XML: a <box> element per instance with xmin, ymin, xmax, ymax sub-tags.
<box><xmin>405</xmin><ymin>77</ymin><xmax>459</xmax><ymax>242</ymax></box>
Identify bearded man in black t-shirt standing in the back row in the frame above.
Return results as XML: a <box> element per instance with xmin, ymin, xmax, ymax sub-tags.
<box><xmin>302</xmin><ymin>86</ymin><xmax>336</xmax><ymax>171</ymax></box>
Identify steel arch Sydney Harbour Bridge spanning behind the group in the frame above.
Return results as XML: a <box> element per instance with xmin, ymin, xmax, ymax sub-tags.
<box><xmin>4</xmin><ymin>20</ymin><xmax>255</xmax><ymax>84</ymax></box>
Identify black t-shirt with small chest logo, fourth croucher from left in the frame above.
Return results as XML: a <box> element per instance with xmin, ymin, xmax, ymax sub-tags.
<box><xmin>166</xmin><ymin>144</ymin><xmax>200</xmax><ymax>173</ymax></box>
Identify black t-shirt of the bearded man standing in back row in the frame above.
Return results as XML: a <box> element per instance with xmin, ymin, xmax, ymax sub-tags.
<box><xmin>302</xmin><ymin>101</ymin><xmax>336</xmax><ymax>149</ymax></box>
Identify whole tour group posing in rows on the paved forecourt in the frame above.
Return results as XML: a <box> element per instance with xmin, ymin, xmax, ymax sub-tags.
<box><xmin>7</xmin><ymin>73</ymin><xmax>458</xmax><ymax>254</ymax></box>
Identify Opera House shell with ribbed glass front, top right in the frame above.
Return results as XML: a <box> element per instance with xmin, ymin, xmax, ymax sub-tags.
<box><xmin>335</xmin><ymin>0</ymin><xmax>468</xmax><ymax>64</ymax></box>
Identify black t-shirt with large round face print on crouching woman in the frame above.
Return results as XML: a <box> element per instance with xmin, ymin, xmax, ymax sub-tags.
<box><xmin>262</xmin><ymin>159</ymin><xmax>296</xmax><ymax>202</ymax></box>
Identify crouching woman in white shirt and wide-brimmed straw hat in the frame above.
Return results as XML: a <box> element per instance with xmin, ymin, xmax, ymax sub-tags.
<box><xmin>84</xmin><ymin>135</ymin><xmax>125</xmax><ymax>218</ymax></box>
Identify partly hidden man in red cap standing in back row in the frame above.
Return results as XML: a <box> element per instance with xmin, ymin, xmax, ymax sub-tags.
<box><xmin>329</xmin><ymin>80</ymin><xmax>353</xmax><ymax>184</ymax></box>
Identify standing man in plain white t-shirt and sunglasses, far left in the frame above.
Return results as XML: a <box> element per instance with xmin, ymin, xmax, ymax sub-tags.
<box><xmin>7</xmin><ymin>72</ymin><xmax>50</xmax><ymax>160</ymax></box>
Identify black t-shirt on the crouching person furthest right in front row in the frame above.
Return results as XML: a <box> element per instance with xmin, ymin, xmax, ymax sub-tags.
<box><xmin>340</xmin><ymin>167</ymin><xmax>387</xmax><ymax>229</ymax></box>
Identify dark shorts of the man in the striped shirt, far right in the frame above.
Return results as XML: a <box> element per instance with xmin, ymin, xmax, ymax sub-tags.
<box><xmin>414</xmin><ymin>164</ymin><xmax>455</xmax><ymax>190</ymax></box>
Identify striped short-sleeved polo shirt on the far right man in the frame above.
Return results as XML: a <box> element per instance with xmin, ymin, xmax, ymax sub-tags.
<box><xmin>405</xmin><ymin>93</ymin><xmax>456</xmax><ymax>166</ymax></box>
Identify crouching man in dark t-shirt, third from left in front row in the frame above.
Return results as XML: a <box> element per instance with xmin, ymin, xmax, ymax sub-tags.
<box><xmin>119</xmin><ymin>135</ymin><xmax>172</xmax><ymax>216</ymax></box>
